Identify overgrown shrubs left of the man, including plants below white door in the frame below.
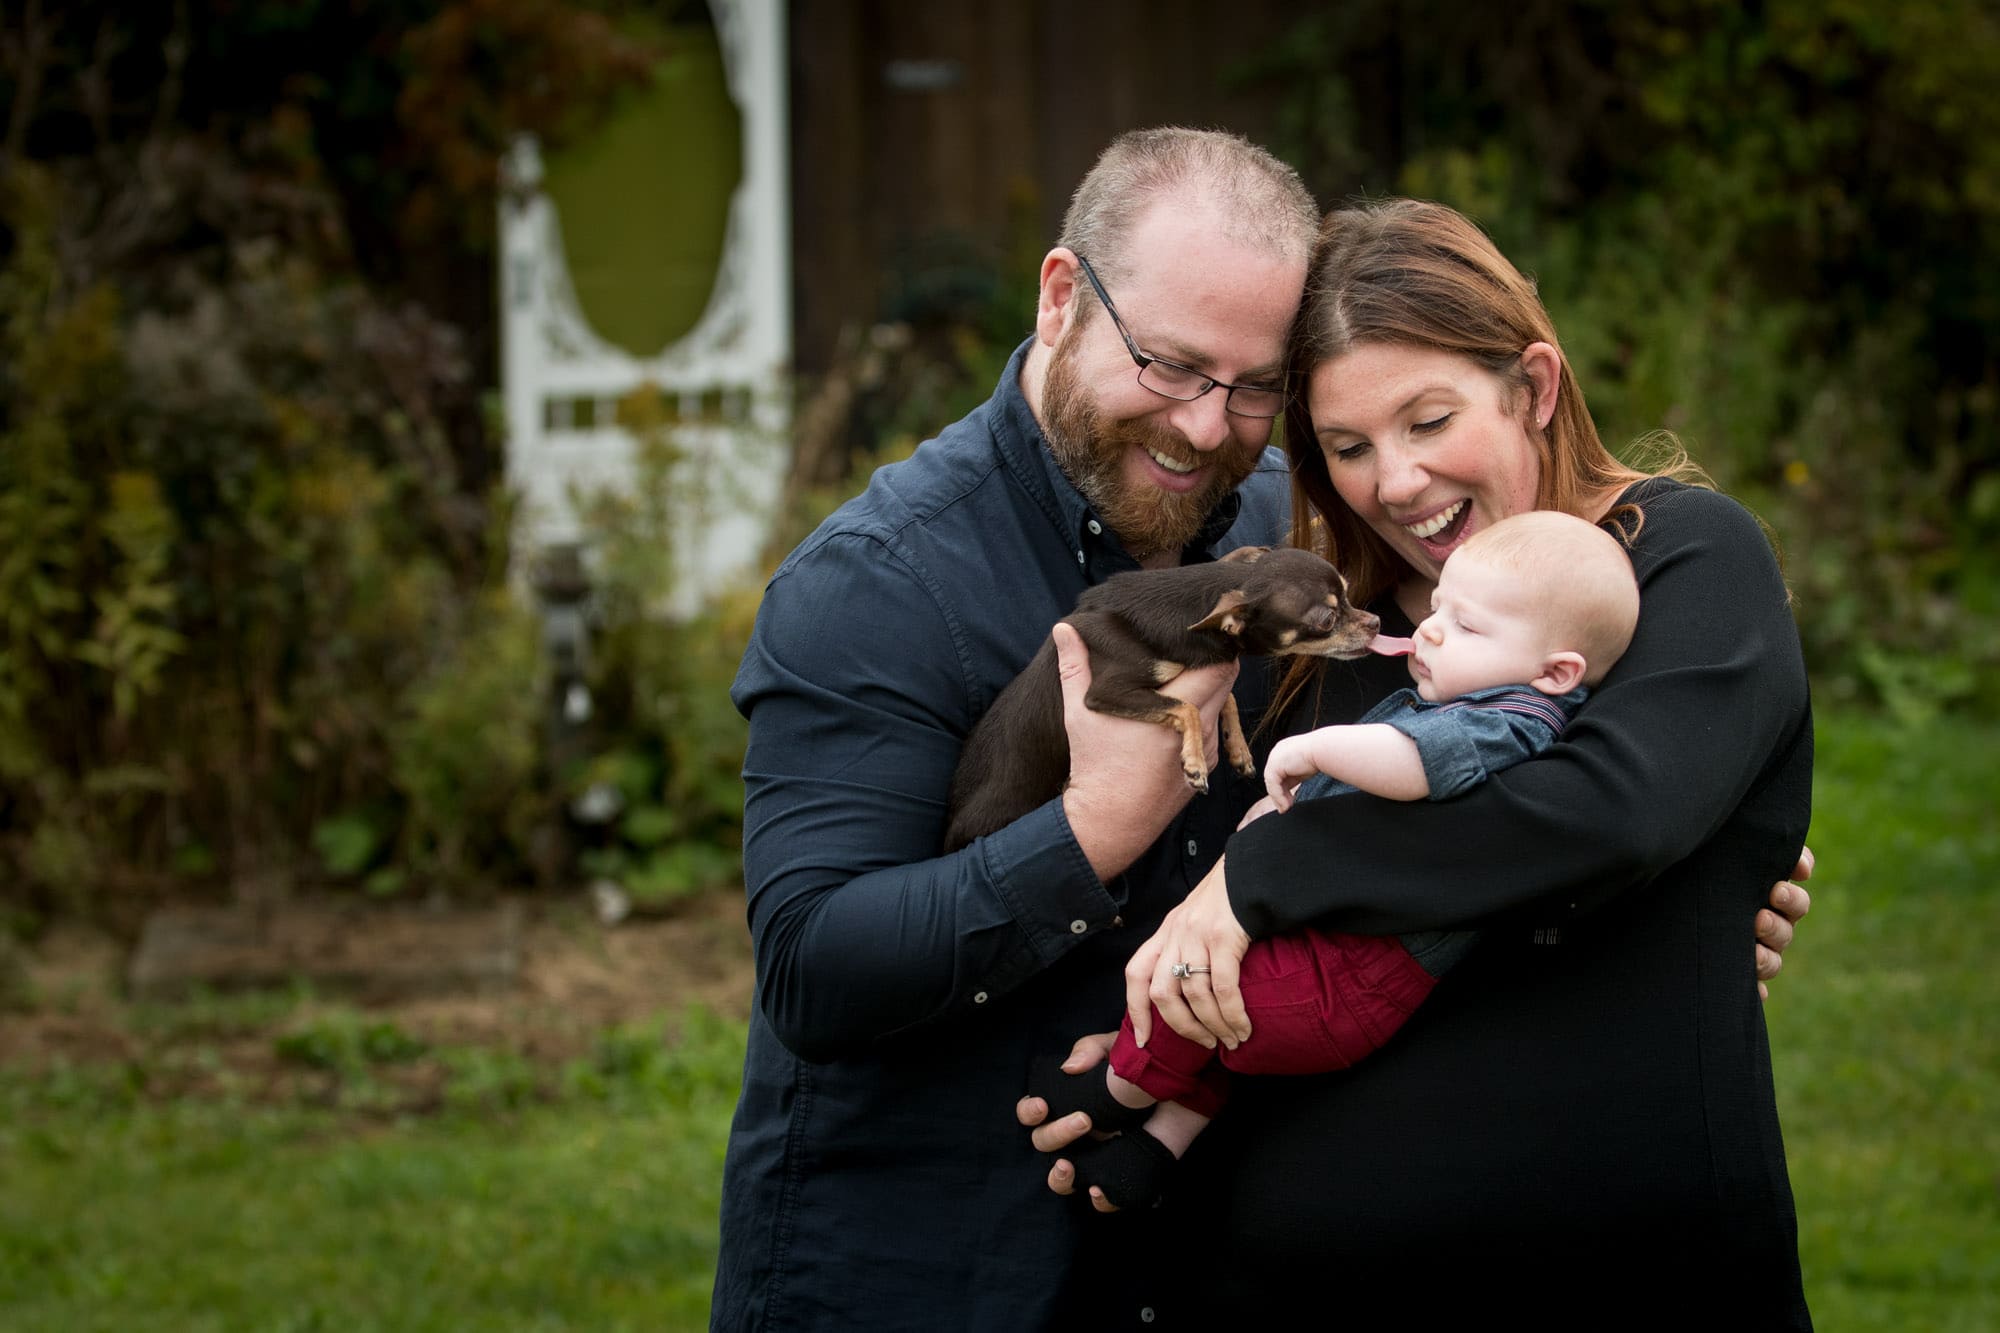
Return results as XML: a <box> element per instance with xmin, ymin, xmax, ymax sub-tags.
<box><xmin>0</xmin><ymin>132</ymin><xmax>776</xmax><ymax>905</ymax></box>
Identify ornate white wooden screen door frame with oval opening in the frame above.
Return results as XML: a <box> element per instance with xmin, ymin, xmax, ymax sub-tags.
<box><xmin>500</xmin><ymin>0</ymin><xmax>792</xmax><ymax>610</ymax></box>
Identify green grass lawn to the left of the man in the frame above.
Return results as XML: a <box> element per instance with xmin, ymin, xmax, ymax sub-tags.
<box><xmin>0</xmin><ymin>1015</ymin><xmax>742</xmax><ymax>1333</ymax></box>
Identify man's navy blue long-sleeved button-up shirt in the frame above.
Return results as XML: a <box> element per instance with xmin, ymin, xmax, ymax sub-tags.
<box><xmin>712</xmin><ymin>344</ymin><xmax>1290</xmax><ymax>1333</ymax></box>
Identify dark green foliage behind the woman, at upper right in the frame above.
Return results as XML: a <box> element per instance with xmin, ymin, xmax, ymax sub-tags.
<box><xmin>1238</xmin><ymin>0</ymin><xmax>2000</xmax><ymax>715</ymax></box>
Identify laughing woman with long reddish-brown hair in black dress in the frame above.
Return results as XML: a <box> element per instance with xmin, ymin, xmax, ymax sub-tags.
<box><xmin>1096</xmin><ymin>200</ymin><xmax>1812</xmax><ymax>1329</ymax></box>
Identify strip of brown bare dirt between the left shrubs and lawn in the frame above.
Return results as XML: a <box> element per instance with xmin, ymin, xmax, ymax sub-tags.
<box><xmin>0</xmin><ymin>880</ymin><xmax>752</xmax><ymax>1091</ymax></box>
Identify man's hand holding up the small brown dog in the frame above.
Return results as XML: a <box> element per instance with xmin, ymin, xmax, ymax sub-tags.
<box><xmin>1054</xmin><ymin>622</ymin><xmax>1236</xmax><ymax>881</ymax></box>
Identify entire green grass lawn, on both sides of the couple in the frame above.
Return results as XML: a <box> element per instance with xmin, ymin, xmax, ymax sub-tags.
<box><xmin>0</xmin><ymin>700</ymin><xmax>2000</xmax><ymax>1333</ymax></box>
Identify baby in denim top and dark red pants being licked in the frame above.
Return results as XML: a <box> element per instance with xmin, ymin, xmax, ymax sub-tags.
<box><xmin>1030</xmin><ymin>510</ymin><xmax>1638</xmax><ymax>1207</ymax></box>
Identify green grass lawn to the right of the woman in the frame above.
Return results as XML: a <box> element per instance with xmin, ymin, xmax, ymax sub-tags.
<box><xmin>1768</xmin><ymin>717</ymin><xmax>2000</xmax><ymax>1331</ymax></box>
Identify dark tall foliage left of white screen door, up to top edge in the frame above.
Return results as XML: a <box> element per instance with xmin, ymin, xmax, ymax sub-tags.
<box><xmin>0</xmin><ymin>0</ymin><xmax>692</xmax><ymax>913</ymax></box>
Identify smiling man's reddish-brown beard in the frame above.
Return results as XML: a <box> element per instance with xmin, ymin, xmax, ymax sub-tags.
<box><xmin>1042</xmin><ymin>326</ymin><xmax>1262</xmax><ymax>560</ymax></box>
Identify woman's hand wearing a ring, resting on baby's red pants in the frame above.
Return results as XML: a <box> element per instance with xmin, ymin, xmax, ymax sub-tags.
<box><xmin>1126</xmin><ymin>861</ymin><xmax>1250</xmax><ymax>1051</ymax></box>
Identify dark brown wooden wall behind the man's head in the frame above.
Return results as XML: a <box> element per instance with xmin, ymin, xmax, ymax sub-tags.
<box><xmin>790</xmin><ymin>0</ymin><xmax>1298</xmax><ymax>374</ymax></box>
